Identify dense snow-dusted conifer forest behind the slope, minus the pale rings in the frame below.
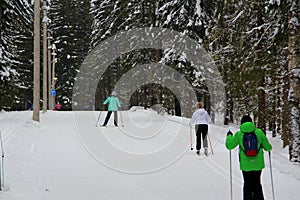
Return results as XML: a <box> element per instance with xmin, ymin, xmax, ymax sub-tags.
<box><xmin>0</xmin><ymin>0</ymin><xmax>300</xmax><ymax>162</ymax></box>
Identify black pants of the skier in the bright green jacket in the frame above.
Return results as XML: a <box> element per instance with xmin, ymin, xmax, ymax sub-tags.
<box><xmin>242</xmin><ymin>170</ymin><xmax>264</xmax><ymax>200</ymax></box>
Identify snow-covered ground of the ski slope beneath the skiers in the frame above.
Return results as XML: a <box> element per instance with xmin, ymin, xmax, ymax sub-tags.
<box><xmin>0</xmin><ymin>109</ymin><xmax>300</xmax><ymax>200</ymax></box>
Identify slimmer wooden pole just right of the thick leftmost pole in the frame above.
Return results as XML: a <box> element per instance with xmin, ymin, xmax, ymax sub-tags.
<box><xmin>43</xmin><ymin>1</ymin><xmax>48</xmax><ymax>112</ymax></box>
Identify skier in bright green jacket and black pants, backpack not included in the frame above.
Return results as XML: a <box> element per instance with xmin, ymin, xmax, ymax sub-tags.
<box><xmin>226</xmin><ymin>115</ymin><xmax>272</xmax><ymax>200</ymax></box>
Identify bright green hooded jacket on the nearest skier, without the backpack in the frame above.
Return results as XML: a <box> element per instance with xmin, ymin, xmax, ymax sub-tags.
<box><xmin>226</xmin><ymin>122</ymin><xmax>272</xmax><ymax>171</ymax></box>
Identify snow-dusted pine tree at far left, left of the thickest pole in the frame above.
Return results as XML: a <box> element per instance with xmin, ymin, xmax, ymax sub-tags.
<box><xmin>0</xmin><ymin>0</ymin><xmax>33</xmax><ymax>110</ymax></box>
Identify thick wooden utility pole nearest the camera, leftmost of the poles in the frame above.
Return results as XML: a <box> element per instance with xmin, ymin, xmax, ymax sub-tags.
<box><xmin>32</xmin><ymin>0</ymin><xmax>41</xmax><ymax>121</ymax></box>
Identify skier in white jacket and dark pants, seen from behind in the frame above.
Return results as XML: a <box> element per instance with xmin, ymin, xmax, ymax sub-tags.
<box><xmin>190</xmin><ymin>102</ymin><xmax>210</xmax><ymax>156</ymax></box>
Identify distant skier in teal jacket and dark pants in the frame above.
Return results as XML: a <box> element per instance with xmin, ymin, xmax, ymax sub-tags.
<box><xmin>102</xmin><ymin>91</ymin><xmax>121</xmax><ymax>126</ymax></box>
